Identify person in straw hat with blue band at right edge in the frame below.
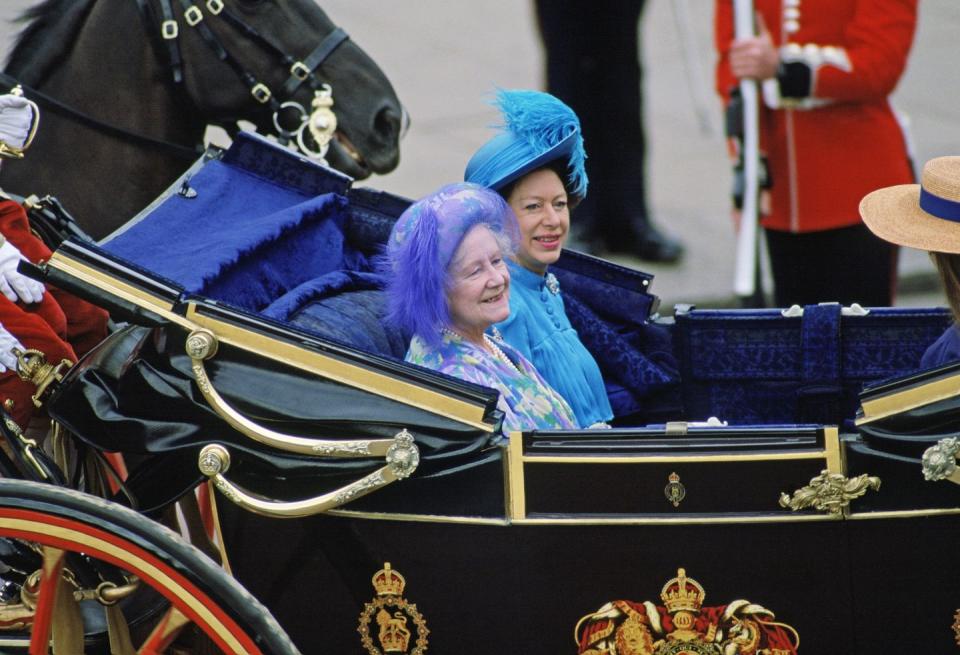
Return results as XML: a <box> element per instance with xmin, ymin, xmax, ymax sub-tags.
<box><xmin>860</xmin><ymin>157</ymin><xmax>960</xmax><ymax>368</ymax></box>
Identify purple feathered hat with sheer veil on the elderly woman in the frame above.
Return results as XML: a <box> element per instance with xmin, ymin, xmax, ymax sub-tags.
<box><xmin>385</xmin><ymin>182</ymin><xmax>520</xmax><ymax>345</ymax></box>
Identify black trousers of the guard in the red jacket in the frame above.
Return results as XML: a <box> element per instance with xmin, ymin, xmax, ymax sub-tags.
<box><xmin>764</xmin><ymin>223</ymin><xmax>898</xmax><ymax>307</ymax></box>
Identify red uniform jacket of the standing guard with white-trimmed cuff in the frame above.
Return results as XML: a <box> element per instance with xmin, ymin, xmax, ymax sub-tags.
<box><xmin>715</xmin><ymin>0</ymin><xmax>917</xmax><ymax>232</ymax></box>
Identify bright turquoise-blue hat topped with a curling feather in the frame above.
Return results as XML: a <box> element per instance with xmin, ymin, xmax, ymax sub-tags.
<box><xmin>463</xmin><ymin>89</ymin><xmax>587</xmax><ymax>199</ymax></box>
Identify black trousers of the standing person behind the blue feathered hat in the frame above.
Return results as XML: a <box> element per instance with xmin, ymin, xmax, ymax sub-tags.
<box><xmin>536</xmin><ymin>0</ymin><xmax>649</xmax><ymax>241</ymax></box>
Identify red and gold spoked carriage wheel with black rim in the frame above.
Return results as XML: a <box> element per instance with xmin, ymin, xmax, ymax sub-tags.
<box><xmin>0</xmin><ymin>480</ymin><xmax>298</xmax><ymax>655</ymax></box>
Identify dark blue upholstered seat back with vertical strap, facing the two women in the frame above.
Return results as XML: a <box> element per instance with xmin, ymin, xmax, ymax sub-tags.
<box><xmin>673</xmin><ymin>305</ymin><xmax>950</xmax><ymax>425</ymax></box>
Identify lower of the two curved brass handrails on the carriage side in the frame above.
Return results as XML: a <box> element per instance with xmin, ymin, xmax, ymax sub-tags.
<box><xmin>197</xmin><ymin>430</ymin><xmax>420</xmax><ymax>518</ymax></box>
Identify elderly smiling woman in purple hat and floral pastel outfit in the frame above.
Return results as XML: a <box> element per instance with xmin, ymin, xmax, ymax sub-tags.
<box><xmin>386</xmin><ymin>183</ymin><xmax>578</xmax><ymax>432</ymax></box>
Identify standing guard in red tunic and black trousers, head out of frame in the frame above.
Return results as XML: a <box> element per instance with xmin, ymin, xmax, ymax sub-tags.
<box><xmin>715</xmin><ymin>0</ymin><xmax>917</xmax><ymax>307</ymax></box>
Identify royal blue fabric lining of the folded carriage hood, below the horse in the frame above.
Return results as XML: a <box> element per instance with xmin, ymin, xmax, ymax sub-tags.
<box><xmin>104</xmin><ymin>161</ymin><xmax>365</xmax><ymax>311</ymax></box>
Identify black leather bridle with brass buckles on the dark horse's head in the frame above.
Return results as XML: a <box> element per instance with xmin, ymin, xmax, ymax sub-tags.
<box><xmin>136</xmin><ymin>0</ymin><xmax>350</xmax><ymax>161</ymax></box>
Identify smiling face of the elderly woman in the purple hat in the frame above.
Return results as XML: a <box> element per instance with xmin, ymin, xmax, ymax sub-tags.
<box><xmin>447</xmin><ymin>225</ymin><xmax>510</xmax><ymax>343</ymax></box>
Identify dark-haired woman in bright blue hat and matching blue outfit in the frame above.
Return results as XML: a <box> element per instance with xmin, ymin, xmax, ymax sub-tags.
<box><xmin>464</xmin><ymin>90</ymin><xmax>613</xmax><ymax>427</ymax></box>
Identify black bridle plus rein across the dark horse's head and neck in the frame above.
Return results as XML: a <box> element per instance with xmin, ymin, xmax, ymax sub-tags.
<box><xmin>0</xmin><ymin>0</ymin><xmax>350</xmax><ymax>161</ymax></box>
